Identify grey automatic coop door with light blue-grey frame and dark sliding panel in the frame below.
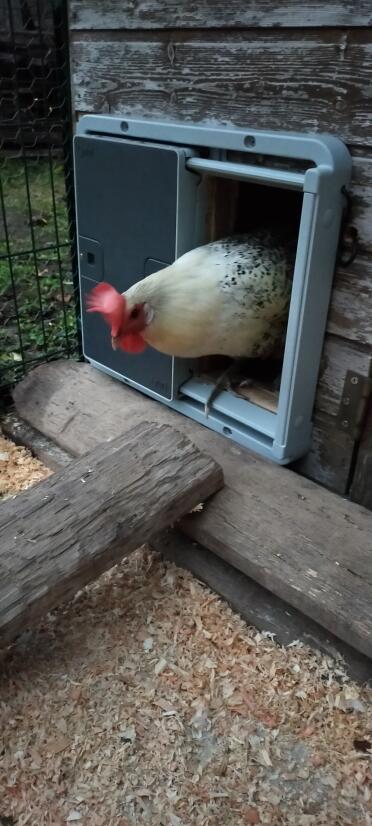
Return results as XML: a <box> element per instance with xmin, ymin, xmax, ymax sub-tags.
<box><xmin>74</xmin><ymin>115</ymin><xmax>351</xmax><ymax>464</ymax></box>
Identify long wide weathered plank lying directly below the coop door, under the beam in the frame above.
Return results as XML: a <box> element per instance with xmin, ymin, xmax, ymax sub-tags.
<box><xmin>14</xmin><ymin>362</ymin><xmax>372</xmax><ymax>657</ymax></box>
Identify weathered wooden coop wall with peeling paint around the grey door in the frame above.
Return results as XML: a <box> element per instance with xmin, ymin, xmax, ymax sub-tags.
<box><xmin>70</xmin><ymin>0</ymin><xmax>372</xmax><ymax>507</ymax></box>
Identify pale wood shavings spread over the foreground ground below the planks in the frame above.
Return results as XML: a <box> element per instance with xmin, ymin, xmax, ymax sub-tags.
<box><xmin>0</xmin><ymin>434</ymin><xmax>372</xmax><ymax>826</ymax></box>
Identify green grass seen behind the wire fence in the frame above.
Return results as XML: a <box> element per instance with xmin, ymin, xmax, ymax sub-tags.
<box><xmin>0</xmin><ymin>158</ymin><xmax>78</xmax><ymax>384</ymax></box>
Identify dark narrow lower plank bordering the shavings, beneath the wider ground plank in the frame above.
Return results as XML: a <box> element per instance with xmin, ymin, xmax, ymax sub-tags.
<box><xmin>155</xmin><ymin>529</ymin><xmax>372</xmax><ymax>682</ymax></box>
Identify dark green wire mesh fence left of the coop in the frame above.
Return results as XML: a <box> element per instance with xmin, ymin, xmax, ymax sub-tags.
<box><xmin>0</xmin><ymin>0</ymin><xmax>80</xmax><ymax>390</ymax></box>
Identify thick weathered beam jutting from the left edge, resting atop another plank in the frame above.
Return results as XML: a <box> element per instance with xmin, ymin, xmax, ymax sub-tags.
<box><xmin>0</xmin><ymin>422</ymin><xmax>223</xmax><ymax>644</ymax></box>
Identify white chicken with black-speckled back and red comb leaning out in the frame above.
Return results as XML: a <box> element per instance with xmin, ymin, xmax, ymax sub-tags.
<box><xmin>87</xmin><ymin>230</ymin><xmax>294</xmax><ymax>413</ymax></box>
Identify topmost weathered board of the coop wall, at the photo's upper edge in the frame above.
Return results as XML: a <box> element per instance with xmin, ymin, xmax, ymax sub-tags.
<box><xmin>70</xmin><ymin>0</ymin><xmax>372</xmax><ymax>29</ymax></box>
